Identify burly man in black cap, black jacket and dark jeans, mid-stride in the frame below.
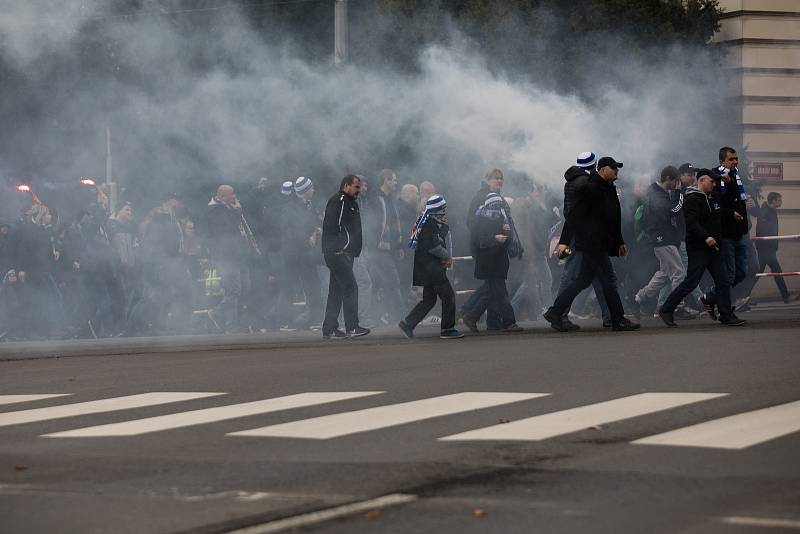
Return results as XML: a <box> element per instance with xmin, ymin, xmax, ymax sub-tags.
<box><xmin>544</xmin><ymin>157</ymin><xmax>639</xmax><ymax>332</ymax></box>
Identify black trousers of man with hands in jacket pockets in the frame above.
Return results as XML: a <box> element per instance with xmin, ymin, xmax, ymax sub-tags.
<box><xmin>322</xmin><ymin>254</ymin><xmax>358</xmax><ymax>335</ymax></box>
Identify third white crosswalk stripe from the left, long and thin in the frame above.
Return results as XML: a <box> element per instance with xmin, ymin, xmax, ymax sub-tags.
<box><xmin>42</xmin><ymin>391</ymin><xmax>383</xmax><ymax>438</ymax></box>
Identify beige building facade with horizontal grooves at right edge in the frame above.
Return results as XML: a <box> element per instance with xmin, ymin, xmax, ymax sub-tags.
<box><xmin>714</xmin><ymin>0</ymin><xmax>800</xmax><ymax>297</ymax></box>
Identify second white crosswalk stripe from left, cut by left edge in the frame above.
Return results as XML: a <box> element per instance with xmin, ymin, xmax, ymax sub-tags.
<box><xmin>0</xmin><ymin>391</ymin><xmax>225</xmax><ymax>426</ymax></box>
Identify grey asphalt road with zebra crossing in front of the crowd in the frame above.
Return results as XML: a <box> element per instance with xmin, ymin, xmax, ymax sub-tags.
<box><xmin>0</xmin><ymin>306</ymin><xmax>800</xmax><ymax>534</ymax></box>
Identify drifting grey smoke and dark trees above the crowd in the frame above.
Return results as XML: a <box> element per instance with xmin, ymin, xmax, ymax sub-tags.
<box><xmin>0</xmin><ymin>0</ymin><xmax>730</xmax><ymax>216</ymax></box>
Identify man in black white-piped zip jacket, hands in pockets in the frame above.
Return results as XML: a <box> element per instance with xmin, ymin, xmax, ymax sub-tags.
<box><xmin>322</xmin><ymin>178</ymin><xmax>369</xmax><ymax>339</ymax></box>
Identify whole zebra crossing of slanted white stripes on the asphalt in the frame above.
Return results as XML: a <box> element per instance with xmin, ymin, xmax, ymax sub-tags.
<box><xmin>0</xmin><ymin>391</ymin><xmax>800</xmax><ymax>450</ymax></box>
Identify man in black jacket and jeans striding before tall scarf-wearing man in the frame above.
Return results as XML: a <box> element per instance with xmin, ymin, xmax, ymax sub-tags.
<box><xmin>658</xmin><ymin>169</ymin><xmax>745</xmax><ymax>327</ymax></box>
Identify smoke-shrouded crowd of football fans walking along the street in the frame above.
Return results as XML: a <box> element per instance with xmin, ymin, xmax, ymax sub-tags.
<box><xmin>0</xmin><ymin>147</ymin><xmax>790</xmax><ymax>340</ymax></box>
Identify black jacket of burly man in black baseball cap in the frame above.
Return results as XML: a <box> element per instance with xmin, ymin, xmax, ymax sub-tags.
<box><xmin>561</xmin><ymin>172</ymin><xmax>625</xmax><ymax>256</ymax></box>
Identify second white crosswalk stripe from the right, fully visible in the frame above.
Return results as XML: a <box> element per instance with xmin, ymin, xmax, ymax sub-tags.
<box><xmin>439</xmin><ymin>393</ymin><xmax>727</xmax><ymax>441</ymax></box>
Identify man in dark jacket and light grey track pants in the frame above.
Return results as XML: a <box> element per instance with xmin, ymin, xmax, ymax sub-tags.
<box><xmin>634</xmin><ymin>165</ymin><xmax>686</xmax><ymax>309</ymax></box>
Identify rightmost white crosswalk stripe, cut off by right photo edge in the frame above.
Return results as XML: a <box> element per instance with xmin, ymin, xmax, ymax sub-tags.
<box><xmin>633</xmin><ymin>401</ymin><xmax>800</xmax><ymax>450</ymax></box>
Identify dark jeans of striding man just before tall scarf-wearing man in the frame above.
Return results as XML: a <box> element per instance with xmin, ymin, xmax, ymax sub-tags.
<box><xmin>661</xmin><ymin>249</ymin><xmax>733</xmax><ymax>321</ymax></box>
